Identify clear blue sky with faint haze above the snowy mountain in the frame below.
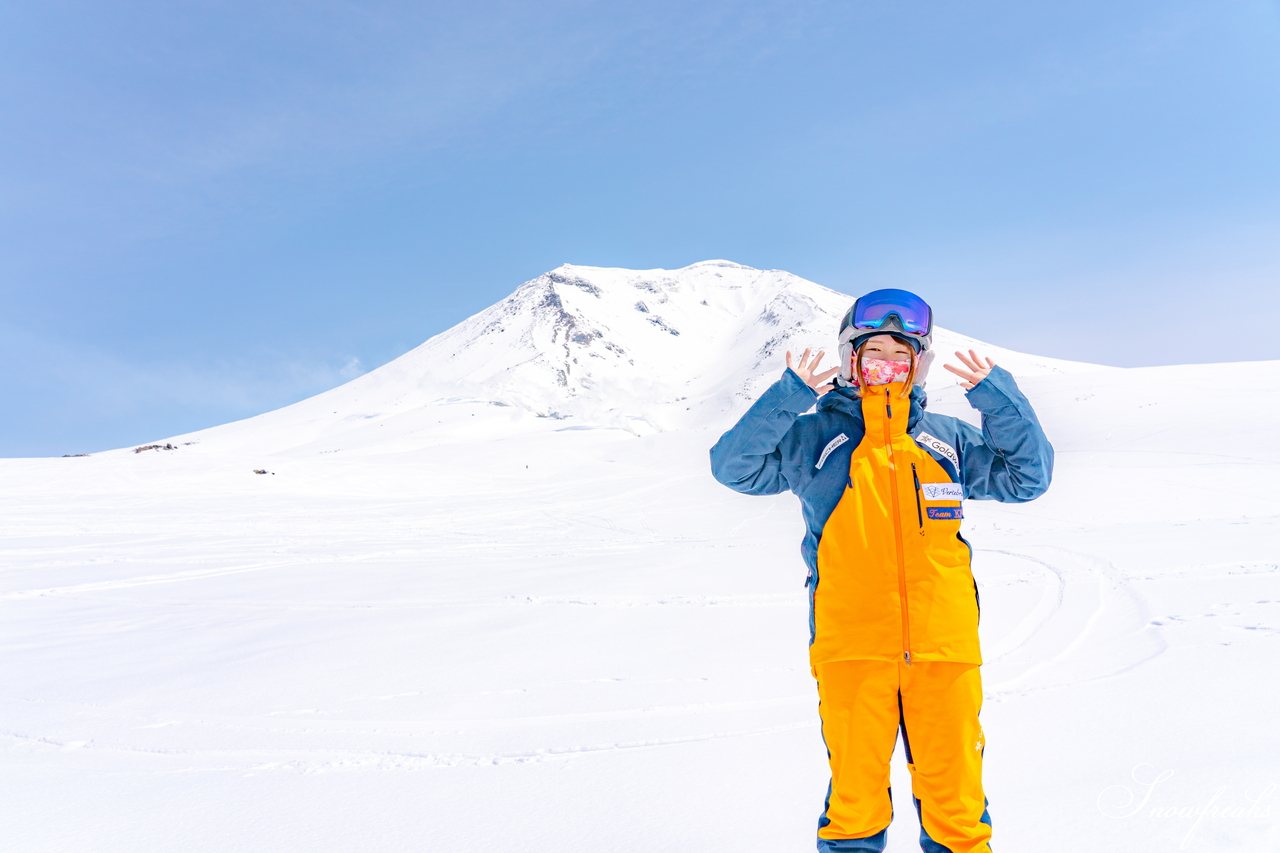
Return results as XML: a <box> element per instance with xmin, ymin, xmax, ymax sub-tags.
<box><xmin>0</xmin><ymin>0</ymin><xmax>1280</xmax><ymax>456</ymax></box>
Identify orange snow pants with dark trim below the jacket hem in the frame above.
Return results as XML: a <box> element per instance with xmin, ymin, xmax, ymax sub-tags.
<box><xmin>814</xmin><ymin>661</ymin><xmax>991</xmax><ymax>853</ymax></box>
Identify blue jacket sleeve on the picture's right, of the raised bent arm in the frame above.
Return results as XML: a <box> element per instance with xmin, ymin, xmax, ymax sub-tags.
<box><xmin>956</xmin><ymin>366</ymin><xmax>1053</xmax><ymax>503</ymax></box>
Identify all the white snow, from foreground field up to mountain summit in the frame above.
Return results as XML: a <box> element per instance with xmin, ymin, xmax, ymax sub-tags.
<box><xmin>0</xmin><ymin>261</ymin><xmax>1280</xmax><ymax>853</ymax></box>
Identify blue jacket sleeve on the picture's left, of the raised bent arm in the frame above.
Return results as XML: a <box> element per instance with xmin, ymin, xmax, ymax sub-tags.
<box><xmin>712</xmin><ymin>368</ymin><xmax>818</xmax><ymax>494</ymax></box>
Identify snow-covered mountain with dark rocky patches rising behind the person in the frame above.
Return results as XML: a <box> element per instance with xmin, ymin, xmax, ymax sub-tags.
<box><xmin>183</xmin><ymin>261</ymin><xmax>1097</xmax><ymax>451</ymax></box>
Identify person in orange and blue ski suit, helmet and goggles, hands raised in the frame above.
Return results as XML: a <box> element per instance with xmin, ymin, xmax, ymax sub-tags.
<box><xmin>710</xmin><ymin>289</ymin><xmax>1053</xmax><ymax>853</ymax></box>
